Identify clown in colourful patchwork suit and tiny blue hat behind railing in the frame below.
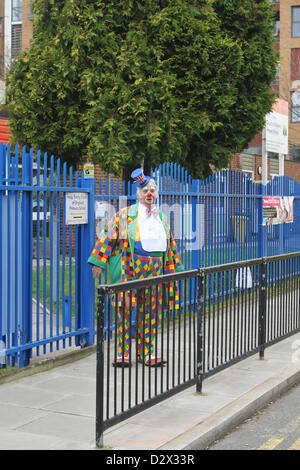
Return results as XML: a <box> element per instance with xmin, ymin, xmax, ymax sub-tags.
<box><xmin>88</xmin><ymin>168</ymin><xmax>184</xmax><ymax>367</ymax></box>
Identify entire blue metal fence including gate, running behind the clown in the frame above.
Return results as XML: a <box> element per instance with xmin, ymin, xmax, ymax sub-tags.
<box><xmin>0</xmin><ymin>144</ymin><xmax>300</xmax><ymax>367</ymax></box>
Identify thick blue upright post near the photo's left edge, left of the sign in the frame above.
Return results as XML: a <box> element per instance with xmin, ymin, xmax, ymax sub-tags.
<box><xmin>20</xmin><ymin>147</ymin><xmax>33</xmax><ymax>367</ymax></box>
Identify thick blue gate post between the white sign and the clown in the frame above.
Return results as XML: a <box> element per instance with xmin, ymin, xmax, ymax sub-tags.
<box><xmin>78</xmin><ymin>171</ymin><xmax>96</xmax><ymax>346</ymax></box>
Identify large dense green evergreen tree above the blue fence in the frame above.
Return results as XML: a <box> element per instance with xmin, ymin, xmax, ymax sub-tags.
<box><xmin>8</xmin><ymin>0</ymin><xmax>277</xmax><ymax>177</ymax></box>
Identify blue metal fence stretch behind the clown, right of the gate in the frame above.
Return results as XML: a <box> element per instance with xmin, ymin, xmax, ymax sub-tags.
<box><xmin>96</xmin><ymin>163</ymin><xmax>300</xmax><ymax>270</ymax></box>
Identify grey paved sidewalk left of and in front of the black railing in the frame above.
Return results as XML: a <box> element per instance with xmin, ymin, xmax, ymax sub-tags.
<box><xmin>0</xmin><ymin>333</ymin><xmax>300</xmax><ymax>451</ymax></box>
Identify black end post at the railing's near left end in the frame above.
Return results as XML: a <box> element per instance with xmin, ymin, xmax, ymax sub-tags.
<box><xmin>96</xmin><ymin>286</ymin><xmax>106</xmax><ymax>448</ymax></box>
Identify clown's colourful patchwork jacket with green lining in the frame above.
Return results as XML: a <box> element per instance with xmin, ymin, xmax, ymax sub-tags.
<box><xmin>88</xmin><ymin>203</ymin><xmax>184</xmax><ymax>284</ymax></box>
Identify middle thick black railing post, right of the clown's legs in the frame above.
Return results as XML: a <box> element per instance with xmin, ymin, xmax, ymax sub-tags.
<box><xmin>196</xmin><ymin>269</ymin><xmax>206</xmax><ymax>393</ymax></box>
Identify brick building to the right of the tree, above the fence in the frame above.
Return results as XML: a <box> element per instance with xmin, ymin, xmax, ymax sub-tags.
<box><xmin>230</xmin><ymin>0</ymin><xmax>300</xmax><ymax>182</ymax></box>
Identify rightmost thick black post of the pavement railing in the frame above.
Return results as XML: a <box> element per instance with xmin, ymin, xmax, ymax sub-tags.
<box><xmin>258</xmin><ymin>258</ymin><xmax>267</xmax><ymax>359</ymax></box>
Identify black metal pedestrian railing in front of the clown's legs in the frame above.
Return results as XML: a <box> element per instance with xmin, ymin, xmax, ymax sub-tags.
<box><xmin>96</xmin><ymin>253</ymin><xmax>300</xmax><ymax>447</ymax></box>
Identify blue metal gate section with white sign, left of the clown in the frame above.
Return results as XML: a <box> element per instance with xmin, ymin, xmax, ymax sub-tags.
<box><xmin>0</xmin><ymin>144</ymin><xmax>95</xmax><ymax>367</ymax></box>
